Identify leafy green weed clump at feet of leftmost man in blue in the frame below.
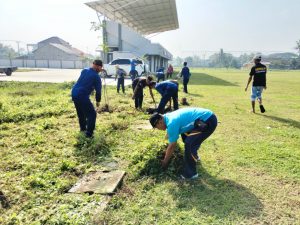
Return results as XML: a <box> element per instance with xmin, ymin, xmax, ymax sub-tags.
<box><xmin>75</xmin><ymin>133</ymin><xmax>111</xmax><ymax>162</ymax></box>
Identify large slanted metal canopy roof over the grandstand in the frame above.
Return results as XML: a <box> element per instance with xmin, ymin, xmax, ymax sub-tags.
<box><xmin>85</xmin><ymin>0</ymin><xmax>179</xmax><ymax>35</ymax></box>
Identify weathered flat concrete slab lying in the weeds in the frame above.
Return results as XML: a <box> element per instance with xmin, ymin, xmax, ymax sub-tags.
<box><xmin>69</xmin><ymin>170</ymin><xmax>125</xmax><ymax>194</ymax></box>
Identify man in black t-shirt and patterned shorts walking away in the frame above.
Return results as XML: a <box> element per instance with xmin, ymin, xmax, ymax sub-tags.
<box><xmin>245</xmin><ymin>56</ymin><xmax>267</xmax><ymax>113</ymax></box>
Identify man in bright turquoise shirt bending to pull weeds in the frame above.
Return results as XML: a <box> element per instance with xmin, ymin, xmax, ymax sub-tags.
<box><xmin>150</xmin><ymin>108</ymin><xmax>218</xmax><ymax>179</ymax></box>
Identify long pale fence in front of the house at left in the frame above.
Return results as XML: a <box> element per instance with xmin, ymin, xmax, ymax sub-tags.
<box><xmin>0</xmin><ymin>59</ymin><xmax>91</xmax><ymax>69</ymax></box>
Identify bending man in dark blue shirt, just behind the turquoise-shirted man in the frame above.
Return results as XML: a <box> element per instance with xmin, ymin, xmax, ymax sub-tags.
<box><xmin>149</xmin><ymin>80</ymin><xmax>178</xmax><ymax>113</ymax></box>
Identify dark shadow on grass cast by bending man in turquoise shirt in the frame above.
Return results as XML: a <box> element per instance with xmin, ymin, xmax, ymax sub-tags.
<box><xmin>172</xmin><ymin>164</ymin><xmax>263</xmax><ymax>219</ymax></box>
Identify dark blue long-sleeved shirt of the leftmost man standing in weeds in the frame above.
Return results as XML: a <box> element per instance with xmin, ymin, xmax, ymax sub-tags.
<box><xmin>72</xmin><ymin>68</ymin><xmax>102</xmax><ymax>102</ymax></box>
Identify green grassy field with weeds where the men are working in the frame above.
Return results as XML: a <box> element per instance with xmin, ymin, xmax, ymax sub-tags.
<box><xmin>0</xmin><ymin>69</ymin><xmax>300</xmax><ymax>225</ymax></box>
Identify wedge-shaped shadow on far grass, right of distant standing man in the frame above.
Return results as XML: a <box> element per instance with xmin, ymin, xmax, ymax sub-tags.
<box><xmin>189</xmin><ymin>73</ymin><xmax>238</xmax><ymax>86</ymax></box>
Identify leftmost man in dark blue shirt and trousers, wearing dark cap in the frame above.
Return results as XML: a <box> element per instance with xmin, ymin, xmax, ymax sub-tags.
<box><xmin>72</xmin><ymin>60</ymin><xmax>103</xmax><ymax>137</ymax></box>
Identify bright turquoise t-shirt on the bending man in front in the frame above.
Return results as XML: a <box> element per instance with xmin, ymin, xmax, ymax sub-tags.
<box><xmin>164</xmin><ymin>108</ymin><xmax>213</xmax><ymax>143</ymax></box>
